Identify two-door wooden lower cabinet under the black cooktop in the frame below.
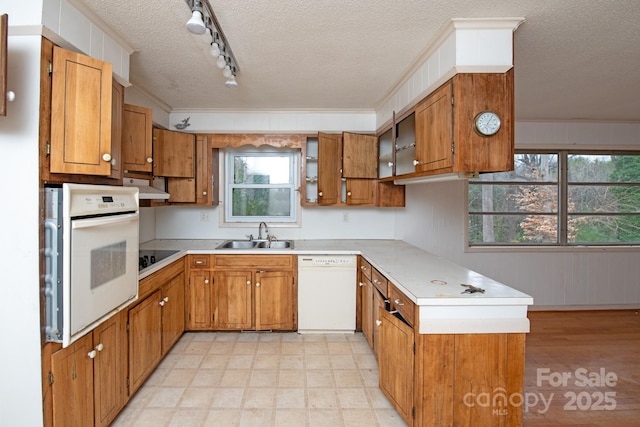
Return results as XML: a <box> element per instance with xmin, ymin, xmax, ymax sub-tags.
<box><xmin>128</xmin><ymin>259</ymin><xmax>185</xmax><ymax>396</ymax></box>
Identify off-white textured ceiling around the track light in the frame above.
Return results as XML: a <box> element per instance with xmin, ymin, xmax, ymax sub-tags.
<box><xmin>83</xmin><ymin>0</ymin><xmax>640</xmax><ymax>121</ymax></box>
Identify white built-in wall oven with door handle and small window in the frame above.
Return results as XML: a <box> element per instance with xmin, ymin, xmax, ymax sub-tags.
<box><xmin>44</xmin><ymin>184</ymin><xmax>139</xmax><ymax>347</ymax></box>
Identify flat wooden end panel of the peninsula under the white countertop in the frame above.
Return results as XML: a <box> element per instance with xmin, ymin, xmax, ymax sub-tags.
<box><xmin>414</xmin><ymin>333</ymin><xmax>525</xmax><ymax>427</ymax></box>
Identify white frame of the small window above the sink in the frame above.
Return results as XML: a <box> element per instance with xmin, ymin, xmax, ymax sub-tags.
<box><xmin>221</xmin><ymin>146</ymin><xmax>301</xmax><ymax>227</ymax></box>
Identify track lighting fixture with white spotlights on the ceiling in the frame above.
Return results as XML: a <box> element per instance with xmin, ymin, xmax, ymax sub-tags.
<box><xmin>185</xmin><ymin>0</ymin><xmax>239</xmax><ymax>88</ymax></box>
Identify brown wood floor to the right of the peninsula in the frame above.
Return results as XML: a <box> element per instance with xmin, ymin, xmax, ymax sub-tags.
<box><xmin>524</xmin><ymin>310</ymin><xmax>640</xmax><ymax>427</ymax></box>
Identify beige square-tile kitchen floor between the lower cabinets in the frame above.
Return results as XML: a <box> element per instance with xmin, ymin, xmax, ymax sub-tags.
<box><xmin>112</xmin><ymin>332</ymin><xmax>406</xmax><ymax>427</ymax></box>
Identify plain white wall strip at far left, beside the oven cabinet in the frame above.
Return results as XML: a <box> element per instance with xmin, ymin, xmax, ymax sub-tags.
<box><xmin>0</xmin><ymin>5</ymin><xmax>42</xmax><ymax>426</ymax></box>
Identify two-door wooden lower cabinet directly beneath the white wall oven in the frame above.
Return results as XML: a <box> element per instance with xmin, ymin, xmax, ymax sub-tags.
<box><xmin>50</xmin><ymin>313</ymin><xmax>127</xmax><ymax>426</ymax></box>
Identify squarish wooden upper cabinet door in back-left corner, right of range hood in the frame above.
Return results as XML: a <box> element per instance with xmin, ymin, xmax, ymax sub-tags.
<box><xmin>153</xmin><ymin>129</ymin><xmax>196</xmax><ymax>178</ymax></box>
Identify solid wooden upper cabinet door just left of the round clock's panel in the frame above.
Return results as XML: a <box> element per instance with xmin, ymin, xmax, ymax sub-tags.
<box><xmin>416</xmin><ymin>82</ymin><xmax>453</xmax><ymax>171</ymax></box>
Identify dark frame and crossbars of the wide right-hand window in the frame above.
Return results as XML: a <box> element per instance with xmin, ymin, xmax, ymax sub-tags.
<box><xmin>465</xmin><ymin>148</ymin><xmax>640</xmax><ymax>252</ymax></box>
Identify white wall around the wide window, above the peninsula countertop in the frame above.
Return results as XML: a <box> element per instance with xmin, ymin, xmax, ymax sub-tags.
<box><xmin>396</xmin><ymin>123</ymin><xmax>640</xmax><ymax>309</ymax></box>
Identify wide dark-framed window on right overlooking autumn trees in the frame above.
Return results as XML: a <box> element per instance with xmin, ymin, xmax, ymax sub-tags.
<box><xmin>468</xmin><ymin>150</ymin><xmax>640</xmax><ymax>246</ymax></box>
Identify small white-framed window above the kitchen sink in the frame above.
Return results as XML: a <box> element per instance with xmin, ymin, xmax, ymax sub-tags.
<box><xmin>225</xmin><ymin>147</ymin><xmax>299</xmax><ymax>223</ymax></box>
